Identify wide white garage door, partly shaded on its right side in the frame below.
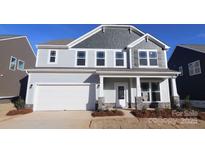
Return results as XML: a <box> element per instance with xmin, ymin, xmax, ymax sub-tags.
<box><xmin>33</xmin><ymin>84</ymin><xmax>96</xmax><ymax>111</ymax></box>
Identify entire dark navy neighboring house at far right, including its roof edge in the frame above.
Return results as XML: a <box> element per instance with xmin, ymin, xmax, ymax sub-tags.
<box><xmin>168</xmin><ymin>44</ymin><xmax>205</xmax><ymax>106</ymax></box>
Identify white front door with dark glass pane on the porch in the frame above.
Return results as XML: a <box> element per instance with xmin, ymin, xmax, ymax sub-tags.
<box><xmin>115</xmin><ymin>83</ymin><xmax>127</xmax><ymax>108</ymax></box>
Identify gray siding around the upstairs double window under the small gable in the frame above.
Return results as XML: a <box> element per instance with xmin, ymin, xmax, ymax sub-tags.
<box><xmin>132</xmin><ymin>40</ymin><xmax>166</xmax><ymax>68</ymax></box>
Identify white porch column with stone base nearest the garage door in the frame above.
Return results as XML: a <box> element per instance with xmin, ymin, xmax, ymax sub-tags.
<box><xmin>97</xmin><ymin>76</ymin><xmax>104</xmax><ymax>110</ymax></box>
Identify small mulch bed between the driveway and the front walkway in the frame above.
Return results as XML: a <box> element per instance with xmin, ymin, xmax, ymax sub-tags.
<box><xmin>91</xmin><ymin>110</ymin><xmax>124</xmax><ymax>117</ymax></box>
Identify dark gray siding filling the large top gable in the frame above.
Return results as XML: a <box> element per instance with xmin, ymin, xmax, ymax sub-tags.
<box><xmin>73</xmin><ymin>28</ymin><xmax>142</xmax><ymax>49</ymax></box>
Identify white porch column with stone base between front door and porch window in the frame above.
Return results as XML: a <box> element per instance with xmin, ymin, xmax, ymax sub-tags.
<box><xmin>135</xmin><ymin>77</ymin><xmax>142</xmax><ymax>110</ymax></box>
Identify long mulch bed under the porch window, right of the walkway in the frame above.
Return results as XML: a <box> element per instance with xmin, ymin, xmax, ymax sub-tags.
<box><xmin>131</xmin><ymin>109</ymin><xmax>201</xmax><ymax>119</ymax></box>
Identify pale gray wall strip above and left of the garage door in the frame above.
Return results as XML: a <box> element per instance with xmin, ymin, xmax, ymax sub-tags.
<box><xmin>26</xmin><ymin>73</ymin><xmax>98</xmax><ymax>104</ymax></box>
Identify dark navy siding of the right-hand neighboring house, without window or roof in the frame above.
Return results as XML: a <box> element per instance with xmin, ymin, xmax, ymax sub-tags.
<box><xmin>168</xmin><ymin>46</ymin><xmax>205</xmax><ymax>100</ymax></box>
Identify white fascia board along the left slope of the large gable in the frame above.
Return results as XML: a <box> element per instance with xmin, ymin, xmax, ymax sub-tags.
<box><xmin>67</xmin><ymin>25</ymin><xmax>103</xmax><ymax>48</ymax></box>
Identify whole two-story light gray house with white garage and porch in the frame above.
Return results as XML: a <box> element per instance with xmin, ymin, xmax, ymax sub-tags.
<box><xmin>26</xmin><ymin>25</ymin><xmax>178</xmax><ymax>111</ymax></box>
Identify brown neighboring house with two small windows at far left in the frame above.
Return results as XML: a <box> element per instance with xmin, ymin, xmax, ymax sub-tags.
<box><xmin>0</xmin><ymin>35</ymin><xmax>36</xmax><ymax>99</ymax></box>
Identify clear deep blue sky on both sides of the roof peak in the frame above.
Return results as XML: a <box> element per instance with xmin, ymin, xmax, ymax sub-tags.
<box><xmin>0</xmin><ymin>24</ymin><xmax>205</xmax><ymax>58</ymax></box>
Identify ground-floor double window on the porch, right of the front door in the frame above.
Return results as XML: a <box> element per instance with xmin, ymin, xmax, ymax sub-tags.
<box><xmin>141</xmin><ymin>82</ymin><xmax>160</xmax><ymax>102</ymax></box>
